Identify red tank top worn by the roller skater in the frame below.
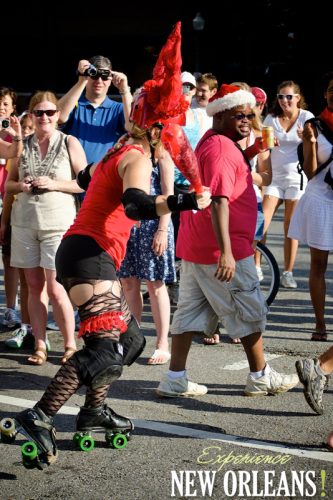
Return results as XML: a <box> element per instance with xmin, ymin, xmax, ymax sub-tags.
<box><xmin>64</xmin><ymin>145</ymin><xmax>143</xmax><ymax>269</ymax></box>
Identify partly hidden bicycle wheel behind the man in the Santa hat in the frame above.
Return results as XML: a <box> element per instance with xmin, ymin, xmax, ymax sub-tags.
<box><xmin>257</xmin><ymin>242</ymin><xmax>280</xmax><ymax>305</ymax></box>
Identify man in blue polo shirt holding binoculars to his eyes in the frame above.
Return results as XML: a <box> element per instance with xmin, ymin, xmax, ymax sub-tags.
<box><xmin>58</xmin><ymin>56</ymin><xmax>132</xmax><ymax>163</ymax></box>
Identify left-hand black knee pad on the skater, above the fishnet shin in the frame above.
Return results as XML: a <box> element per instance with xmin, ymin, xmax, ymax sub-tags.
<box><xmin>71</xmin><ymin>337</ymin><xmax>123</xmax><ymax>389</ymax></box>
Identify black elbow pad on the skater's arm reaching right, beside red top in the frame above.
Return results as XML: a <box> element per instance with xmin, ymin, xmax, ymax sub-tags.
<box><xmin>121</xmin><ymin>188</ymin><xmax>158</xmax><ymax>220</ymax></box>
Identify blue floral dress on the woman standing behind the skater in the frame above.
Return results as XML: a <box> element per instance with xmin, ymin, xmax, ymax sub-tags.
<box><xmin>118</xmin><ymin>164</ymin><xmax>176</xmax><ymax>283</ymax></box>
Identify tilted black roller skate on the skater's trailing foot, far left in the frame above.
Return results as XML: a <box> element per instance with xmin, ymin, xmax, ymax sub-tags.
<box><xmin>0</xmin><ymin>406</ymin><xmax>58</xmax><ymax>469</ymax></box>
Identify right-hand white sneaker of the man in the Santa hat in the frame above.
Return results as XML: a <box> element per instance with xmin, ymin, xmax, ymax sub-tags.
<box><xmin>244</xmin><ymin>368</ymin><xmax>299</xmax><ymax>396</ymax></box>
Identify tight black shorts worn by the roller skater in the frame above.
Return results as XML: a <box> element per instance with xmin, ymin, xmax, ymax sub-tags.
<box><xmin>55</xmin><ymin>234</ymin><xmax>118</xmax><ymax>283</ymax></box>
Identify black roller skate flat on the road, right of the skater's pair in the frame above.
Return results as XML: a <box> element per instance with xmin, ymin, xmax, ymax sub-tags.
<box><xmin>73</xmin><ymin>404</ymin><xmax>134</xmax><ymax>451</ymax></box>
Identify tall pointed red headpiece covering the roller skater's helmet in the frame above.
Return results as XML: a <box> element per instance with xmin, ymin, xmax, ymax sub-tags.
<box><xmin>130</xmin><ymin>22</ymin><xmax>189</xmax><ymax>129</ymax></box>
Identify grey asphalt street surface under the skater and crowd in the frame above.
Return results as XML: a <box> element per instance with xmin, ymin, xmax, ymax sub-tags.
<box><xmin>0</xmin><ymin>210</ymin><xmax>333</xmax><ymax>500</ymax></box>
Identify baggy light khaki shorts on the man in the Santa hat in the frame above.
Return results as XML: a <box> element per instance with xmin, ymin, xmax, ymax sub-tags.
<box><xmin>171</xmin><ymin>256</ymin><xmax>268</xmax><ymax>338</ymax></box>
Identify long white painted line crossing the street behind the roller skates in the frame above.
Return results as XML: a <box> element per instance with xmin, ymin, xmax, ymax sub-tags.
<box><xmin>0</xmin><ymin>395</ymin><xmax>333</xmax><ymax>463</ymax></box>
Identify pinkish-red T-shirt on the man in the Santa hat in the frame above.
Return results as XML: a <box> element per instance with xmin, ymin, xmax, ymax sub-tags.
<box><xmin>176</xmin><ymin>130</ymin><xmax>257</xmax><ymax>264</ymax></box>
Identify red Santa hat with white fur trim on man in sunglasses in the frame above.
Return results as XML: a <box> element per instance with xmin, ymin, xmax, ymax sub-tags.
<box><xmin>206</xmin><ymin>83</ymin><xmax>256</xmax><ymax>116</ymax></box>
